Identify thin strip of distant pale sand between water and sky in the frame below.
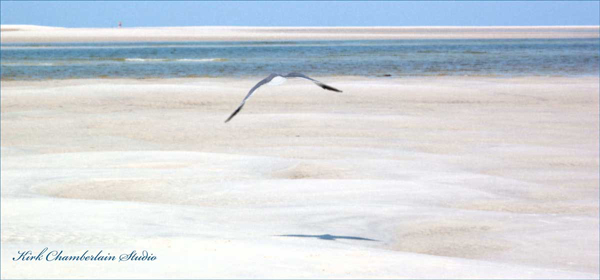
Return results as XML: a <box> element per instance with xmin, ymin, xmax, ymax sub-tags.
<box><xmin>0</xmin><ymin>25</ymin><xmax>600</xmax><ymax>43</ymax></box>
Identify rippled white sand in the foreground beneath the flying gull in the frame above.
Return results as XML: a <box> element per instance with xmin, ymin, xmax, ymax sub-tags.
<box><xmin>1</xmin><ymin>74</ymin><xmax>599</xmax><ymax>279</ymax></box>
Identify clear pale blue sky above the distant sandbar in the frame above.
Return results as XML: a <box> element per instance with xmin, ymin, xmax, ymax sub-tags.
<box><xmin>0</xmin><ymin>1</ymin><xmax>600</xmax><ymax>27</ymax></box>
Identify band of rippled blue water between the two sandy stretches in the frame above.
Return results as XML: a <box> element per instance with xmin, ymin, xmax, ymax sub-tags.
<box><xmin>1</xmin><ymin>39</ymin><xmax>600</xmax><ymax>80</ymax></box>
